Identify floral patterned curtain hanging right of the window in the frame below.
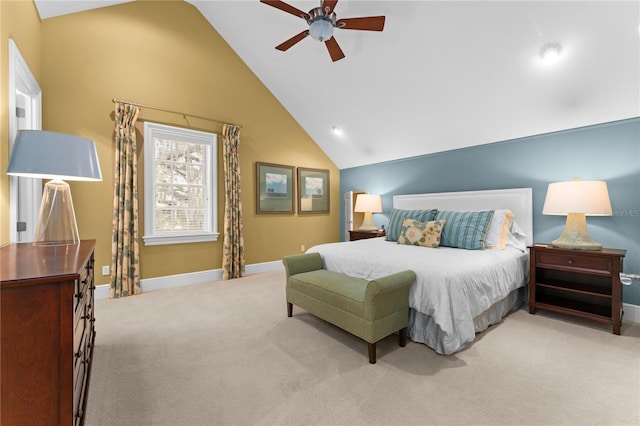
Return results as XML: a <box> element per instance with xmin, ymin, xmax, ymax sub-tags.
<box><xmin>222</xmin><ymin>124</ymin><xmax>244</xmax><ymax>280</ymax></box>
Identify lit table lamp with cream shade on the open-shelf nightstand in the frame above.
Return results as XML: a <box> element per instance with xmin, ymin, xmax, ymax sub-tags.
<box><xmin>542</xmin><ymin>178</ymin><xmax>613</xmax><ymax>250</ymax></box>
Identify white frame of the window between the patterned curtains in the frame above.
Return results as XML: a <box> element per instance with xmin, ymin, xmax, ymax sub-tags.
<box><xmin>142</xmin><ymin>121</ymin><xmax>219</xmax><ymax>246</ymax></box>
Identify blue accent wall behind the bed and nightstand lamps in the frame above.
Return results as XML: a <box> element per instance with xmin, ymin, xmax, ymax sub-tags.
<box><xmin>340</xmin><ymin>118</ymin><xmax>640</xmax><ymax>305</ymax></box>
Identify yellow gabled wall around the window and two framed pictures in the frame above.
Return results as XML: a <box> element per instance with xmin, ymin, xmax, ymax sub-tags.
<box><xmin>2</xmin><ymin>1</ymin><xmax>340</xmax><ymax>284</ymax></box>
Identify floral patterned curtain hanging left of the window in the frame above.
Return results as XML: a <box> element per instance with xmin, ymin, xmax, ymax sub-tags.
<box><xmin>109</xmin><ymin>102</ymin><xmax>140</xmax><ymax>298</ymax></box>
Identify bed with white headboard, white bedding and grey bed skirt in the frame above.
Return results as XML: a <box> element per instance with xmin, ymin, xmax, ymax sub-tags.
<box><xmin>308</xmin><ymin>188</ymin><xmax>533</xmax><ymax>355</ymax></box>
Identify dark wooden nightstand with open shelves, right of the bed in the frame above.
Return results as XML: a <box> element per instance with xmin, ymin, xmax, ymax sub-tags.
<box><xmin>529</xmin><ymin>244</ymin><xmax>626</xmax><ymax>334</ymax></box>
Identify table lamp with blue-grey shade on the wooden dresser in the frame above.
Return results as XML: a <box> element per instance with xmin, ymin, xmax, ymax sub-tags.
<box><xmin>7</xmin><ymin>130</ymin><xmax>102</xmax><ymax>245</ymax></box>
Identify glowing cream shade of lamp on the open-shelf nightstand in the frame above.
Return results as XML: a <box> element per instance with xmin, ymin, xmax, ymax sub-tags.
<box><xmin>542</xmin><ymin>180</ymin><xmax>613</xmax><ymax>216</ymax></box>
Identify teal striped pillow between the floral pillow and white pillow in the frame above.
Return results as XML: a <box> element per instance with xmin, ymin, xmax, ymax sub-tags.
<box><xmin>436</xmin><ymin>210</ymin><xmax>494</xmax><ymax>250</ymax></box>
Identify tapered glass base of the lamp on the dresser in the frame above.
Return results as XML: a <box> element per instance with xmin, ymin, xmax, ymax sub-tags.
<box><xmin>33</xmin><ymin>179</ymin><xmax>80</xmax><ymax>246</ymax></box>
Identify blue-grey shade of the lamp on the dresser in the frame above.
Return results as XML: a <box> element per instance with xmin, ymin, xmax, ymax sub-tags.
<box><xmin>7</xmin><ymin>130</ymin><xmax>102</xmax><ymax>181</ymax></box>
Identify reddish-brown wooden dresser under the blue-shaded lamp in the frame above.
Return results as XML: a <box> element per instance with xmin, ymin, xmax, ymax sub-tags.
<box><xmin>0</xmin><ymin>240</ymin><xmax>95</xmax><ymax>426</ymax></box>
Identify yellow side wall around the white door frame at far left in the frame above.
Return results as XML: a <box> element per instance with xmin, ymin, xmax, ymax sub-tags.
<box><xmin>0</xmin><ymin>1</ymin><xmax>42</xmax><ymax>246</ymax></box>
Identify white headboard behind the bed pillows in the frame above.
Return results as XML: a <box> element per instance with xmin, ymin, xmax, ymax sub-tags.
<box><xmin>393</xmin><ymin>188</ymin><xmax>533</xmax><ymax>245</ymax></box>
